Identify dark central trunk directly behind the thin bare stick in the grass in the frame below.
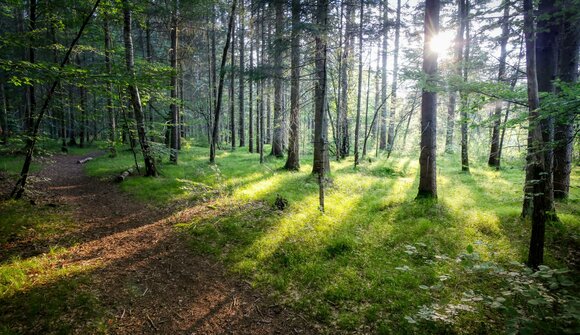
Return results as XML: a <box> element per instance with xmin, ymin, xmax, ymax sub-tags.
<box><xmin>312</xmin><ymin>0</ymin><xmax>330</xmax><ymax>176</ymax></box>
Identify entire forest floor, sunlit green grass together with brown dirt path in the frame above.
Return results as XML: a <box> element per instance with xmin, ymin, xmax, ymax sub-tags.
<box><xmin>0</xmin><ymin>140</ymin><xmax>580</xmax><ymax>334</ymax></box>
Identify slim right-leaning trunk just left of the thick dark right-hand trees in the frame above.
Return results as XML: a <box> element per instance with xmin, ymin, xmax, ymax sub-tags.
<box><xmin>487</xmin><ymin>1</ymin><xmax>510</xmax><ymax>168</ymax></box>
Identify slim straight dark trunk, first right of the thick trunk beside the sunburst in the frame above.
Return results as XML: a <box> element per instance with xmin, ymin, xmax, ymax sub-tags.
<box><xmin>459</xmin><ymin>0</ymin><xmax>471</xmax><ymax>173</ymax></box>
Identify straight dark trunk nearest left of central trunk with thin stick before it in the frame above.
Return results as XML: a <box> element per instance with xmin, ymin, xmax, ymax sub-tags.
<box><xmin>285</xmin><ymin>0</ymin><xmax>300</xmax><ymax>171</ymax></box>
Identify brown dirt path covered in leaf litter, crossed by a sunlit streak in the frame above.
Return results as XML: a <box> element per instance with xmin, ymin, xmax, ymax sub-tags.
<box><xmin>31</xmin><ymin>156</ymin><xmax>315</xmax><ymax>334</ymax></box>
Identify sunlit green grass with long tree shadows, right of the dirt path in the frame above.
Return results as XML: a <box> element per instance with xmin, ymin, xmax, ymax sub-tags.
<box><xmin>86</xmin><ymin>148</ymin><xmax>580</xmax><ymax>333</ymax></box>
